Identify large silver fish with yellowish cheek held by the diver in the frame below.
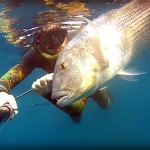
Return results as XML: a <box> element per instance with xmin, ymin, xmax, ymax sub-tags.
<box><xmin>52</xmin><ymin>0</ymin><xmax>150</xmax><ymax>107</ymax></box>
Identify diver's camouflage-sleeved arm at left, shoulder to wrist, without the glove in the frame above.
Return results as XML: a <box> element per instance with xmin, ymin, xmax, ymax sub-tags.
<box><xmin>0</xmin><ymin>50</ymin><xmax>36</xmax><ymax>93</ymax></box>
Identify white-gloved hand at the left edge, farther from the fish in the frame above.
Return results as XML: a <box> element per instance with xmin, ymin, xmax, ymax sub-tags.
<box><xmin>0</xmin><ymin>92</ymin><xmax>18</xmax><ymax>118</ymax></box>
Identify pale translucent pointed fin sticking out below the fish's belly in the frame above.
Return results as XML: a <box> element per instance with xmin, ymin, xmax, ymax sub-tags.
<box><xmin>118</xmin><ymin>67</ymin><xmax>146</xmax><ymax>81</ymax></box>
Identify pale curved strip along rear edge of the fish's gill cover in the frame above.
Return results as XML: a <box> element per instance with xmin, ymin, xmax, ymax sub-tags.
<box><xmin>83</xmin><ymin>17</ymin><xmax>109</xmax><ymax>70</ymax></box>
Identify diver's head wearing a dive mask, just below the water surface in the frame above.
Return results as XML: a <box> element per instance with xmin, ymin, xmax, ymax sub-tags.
<box><xmin>33</xmin><ymin>27</ymin><xmax>67</xmax><ymax>59</ymax></box>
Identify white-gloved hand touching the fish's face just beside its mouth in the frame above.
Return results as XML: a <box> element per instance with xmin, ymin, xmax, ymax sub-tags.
<box><xmin>32</xmin><ymin>73</ymin><xmax>53</xmax><ymax>95</ymax></box>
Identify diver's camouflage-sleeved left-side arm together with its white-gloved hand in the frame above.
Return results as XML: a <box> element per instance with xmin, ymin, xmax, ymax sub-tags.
<box><xmin>0</xmin><ymin>51</ymin><xmax>38</xmax><ymax>121</ymax></box>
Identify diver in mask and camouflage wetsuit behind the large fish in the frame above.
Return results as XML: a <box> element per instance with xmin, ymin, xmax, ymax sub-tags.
<box><xmin>0</xmin><ymin>26</ymin><xmax>87</xmax><ymax>122</ymax></box>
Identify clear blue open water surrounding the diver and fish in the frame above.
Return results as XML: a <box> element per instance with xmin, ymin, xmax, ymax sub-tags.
<box><xmin>0</xmin><ymin>1</ymin><xmax>150</xmax><ymax>148</ymax></box>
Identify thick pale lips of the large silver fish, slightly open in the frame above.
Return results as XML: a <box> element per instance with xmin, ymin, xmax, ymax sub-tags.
<box><xmin>51</xmin><ymin>91</ymin><xmax>74</xmax><ymax>107</ymax></box>
